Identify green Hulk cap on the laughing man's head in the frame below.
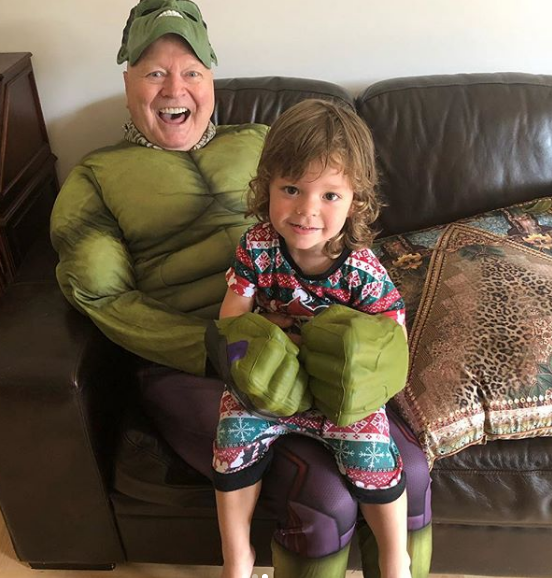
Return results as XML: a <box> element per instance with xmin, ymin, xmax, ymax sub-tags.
<box><xmin>117</xmin><ymin>0</ymin><xmax>217</xmax><ymax>68</ymax></box>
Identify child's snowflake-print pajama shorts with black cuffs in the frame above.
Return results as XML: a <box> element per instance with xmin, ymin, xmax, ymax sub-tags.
<box><xmin>213</xmin><ymin>390</ymin><xmax>406</xmax><ymax>504</ymax></box>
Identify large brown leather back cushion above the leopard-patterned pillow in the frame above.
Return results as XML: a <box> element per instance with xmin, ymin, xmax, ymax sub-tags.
<box><xmin>356</xmin><ymin>73</ymin><xmax>552</xmax><ymax>234</ymax></box>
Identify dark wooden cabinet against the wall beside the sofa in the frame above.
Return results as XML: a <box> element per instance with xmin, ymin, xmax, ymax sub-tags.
<box><xmin>0</xmin><ymin>52</ymin><xmax>59</xmax><ymax>293</ymax></box>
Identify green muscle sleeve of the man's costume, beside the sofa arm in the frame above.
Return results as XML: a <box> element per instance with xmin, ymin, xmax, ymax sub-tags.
<box><xmin>51</xmin><ymin>166</ymin><xmax>206</xmax><ymax>375</ymax></box>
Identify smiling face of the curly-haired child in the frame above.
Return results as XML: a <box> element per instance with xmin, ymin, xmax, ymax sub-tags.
<box><xmin>269</xmin><ymin>162</ymin><xmax>353</xmax><ymax>257</ymax></box>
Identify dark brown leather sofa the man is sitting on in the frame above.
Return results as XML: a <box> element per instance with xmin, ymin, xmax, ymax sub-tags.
<box><xmin>0</xmin><ymin>73</ymin><xmax>552</xmax><ymax>577</ymax></box>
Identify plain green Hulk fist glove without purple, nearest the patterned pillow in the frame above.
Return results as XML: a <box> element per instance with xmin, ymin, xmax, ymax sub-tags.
<box><xmin>299</xmin><ymin>305</ymin><xmax>408</xmax><ymax>426</ymax></box>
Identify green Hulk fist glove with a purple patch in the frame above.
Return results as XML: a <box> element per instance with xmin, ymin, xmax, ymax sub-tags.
<box><xmin>205</xmin><ymin>313</ymin><xmax>312</xmax><ymax>417</ymax></box>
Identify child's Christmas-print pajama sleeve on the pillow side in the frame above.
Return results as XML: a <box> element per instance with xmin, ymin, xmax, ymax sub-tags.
<box><xmin>352</xmin><ymin>251</ymin><xmax>406</xmax><ymax>325</ymax></box>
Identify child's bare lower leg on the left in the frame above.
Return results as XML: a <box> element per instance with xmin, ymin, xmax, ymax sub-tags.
<box><xmin>216</xmin><ymin>481</ymin><xmax>261</xmax><ymax>578</ymax></box>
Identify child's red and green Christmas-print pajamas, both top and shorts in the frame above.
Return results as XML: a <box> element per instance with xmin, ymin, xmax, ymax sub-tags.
<box><xmin>213</xmin><ymin>223</ymin><xmax>405</xmax><ymax>503</ymax></box>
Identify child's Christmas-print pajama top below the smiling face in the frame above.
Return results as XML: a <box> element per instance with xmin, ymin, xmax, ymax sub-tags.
<box><xmin>226</xmin><ymin>223</ymin><xmax>405</xmax><ymax>325</ymax></box>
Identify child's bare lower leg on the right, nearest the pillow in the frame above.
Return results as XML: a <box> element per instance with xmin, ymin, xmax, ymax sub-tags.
<box><xmin>360</xmin><ymin>491</ymin><xmax>410</xmax><ymax>578</ymax></box>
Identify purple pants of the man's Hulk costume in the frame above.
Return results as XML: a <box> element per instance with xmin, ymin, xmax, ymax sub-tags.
<box><xmin>139</xmin><ymin>366</ymin><xmax>431</xmax><ymax>558</ymax></box>
